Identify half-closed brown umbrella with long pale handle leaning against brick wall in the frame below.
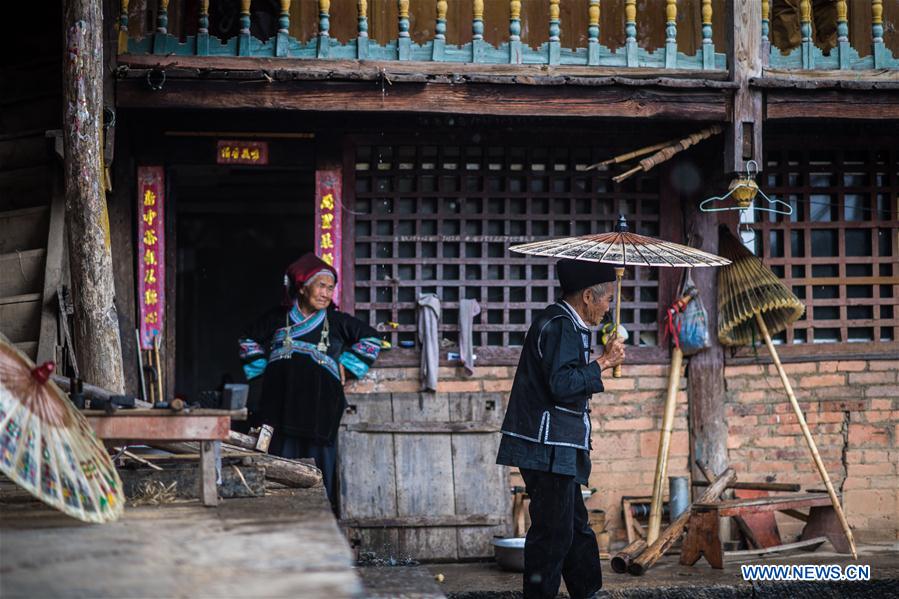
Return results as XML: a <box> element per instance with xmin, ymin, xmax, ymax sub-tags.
<box><xmin>718</xmin><ymin>227</ymin><xmax>858</xmax><ymax>558</ymax></box>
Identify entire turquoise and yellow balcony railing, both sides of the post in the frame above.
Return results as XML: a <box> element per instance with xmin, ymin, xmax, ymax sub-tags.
<box><xmin>113</xmin><ymin>0</ymin><xmax>899</xmax><ymax>71</ymax></box>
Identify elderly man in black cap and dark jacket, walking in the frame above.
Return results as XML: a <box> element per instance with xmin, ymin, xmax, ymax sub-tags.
<box><xmin>496</xmin><ymin>259</ymin><xmax>624</xmax><ymax>598</ymax></box>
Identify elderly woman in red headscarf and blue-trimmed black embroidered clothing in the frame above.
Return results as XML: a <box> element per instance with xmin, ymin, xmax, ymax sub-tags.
<box><xmin>240</xmin><ymin>254</ymin><xmax>382</xmax><ymax>508</ymax></box>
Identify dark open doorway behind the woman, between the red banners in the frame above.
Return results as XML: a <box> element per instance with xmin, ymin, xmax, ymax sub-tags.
<box><xmin>169</xmin><ymin>165</ymin><xmax>314</xmax><ymax>401</ymax></box>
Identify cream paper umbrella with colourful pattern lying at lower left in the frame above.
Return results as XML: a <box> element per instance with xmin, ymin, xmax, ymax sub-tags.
<box><xmin>0</xmin><ymin>339</ymin><xmax>125</xmax><ymax>522</ymax></box>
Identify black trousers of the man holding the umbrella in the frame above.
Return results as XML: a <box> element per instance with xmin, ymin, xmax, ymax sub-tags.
<box><xmin>520</xmin><ymin>468</ymin><xmax>602</xmax><ymax>599</ymax></box>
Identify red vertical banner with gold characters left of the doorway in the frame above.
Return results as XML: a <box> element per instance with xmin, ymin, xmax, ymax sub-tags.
<box><xmin>137</xmin><ymin>166</ymin><xmax>165</xmax><ymax>349</ymax></box>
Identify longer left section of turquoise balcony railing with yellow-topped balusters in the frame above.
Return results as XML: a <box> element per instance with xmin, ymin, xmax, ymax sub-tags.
<box><xmin>118</xmin><ymin>0</ymin><xmax>726</xmax><ymax>70</ymax></box>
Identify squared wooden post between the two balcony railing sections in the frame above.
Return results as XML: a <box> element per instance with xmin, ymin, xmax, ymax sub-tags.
<box><xmin>724</xmin><ymin>0</ymin><xmax>764</xmax><ymax>173</ymax></box>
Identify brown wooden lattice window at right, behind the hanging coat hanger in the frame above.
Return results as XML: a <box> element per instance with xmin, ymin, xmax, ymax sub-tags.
<box><xmin>754</xmin><ymin>142</ymin><xmax>899</xmax><ymax>343</ymax></box>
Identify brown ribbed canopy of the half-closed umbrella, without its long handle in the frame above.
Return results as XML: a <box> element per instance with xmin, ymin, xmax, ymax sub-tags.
<box><xmin>718</xmin><ymin>227</ymin><xmax>805</xmax><ymax>345</ymax></box>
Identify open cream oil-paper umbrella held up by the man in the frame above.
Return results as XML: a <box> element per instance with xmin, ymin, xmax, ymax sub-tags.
<box><xmin>509</xmin><ymin>215</ymin><xmax>730</xmax><ymax>378</ymax></box>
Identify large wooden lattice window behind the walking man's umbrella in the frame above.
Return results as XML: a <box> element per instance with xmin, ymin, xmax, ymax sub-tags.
<box><xmin>353</xmin><ymin>143</ymin><xmax>660</xmax><ymax>347</ymax></box>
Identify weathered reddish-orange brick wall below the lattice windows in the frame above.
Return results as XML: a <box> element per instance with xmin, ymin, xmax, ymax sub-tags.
<box><xmin>348</xmin><ymin>360</ymin><xmax>899</xmax><ymax>542</ymax></box>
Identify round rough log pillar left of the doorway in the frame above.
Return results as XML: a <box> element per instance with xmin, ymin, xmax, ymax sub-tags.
<box><xmin>63</xmin><ymin>0</ymin><xmax>124</xmax><ymax>393</ymax></box>
